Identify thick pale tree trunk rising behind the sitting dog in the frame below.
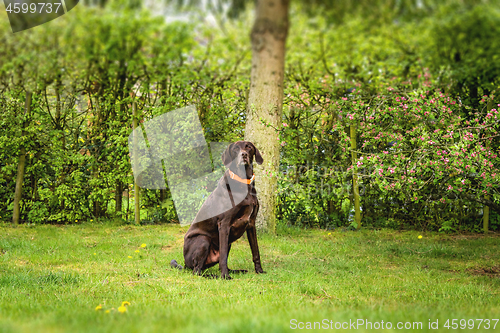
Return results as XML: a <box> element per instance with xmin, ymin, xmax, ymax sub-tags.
<box><xmin>245</xmin><ymin>0</ymin><xmax>289</xmax><ymax>233</ymax></box>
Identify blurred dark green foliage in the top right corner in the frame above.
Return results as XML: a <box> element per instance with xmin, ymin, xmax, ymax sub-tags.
<box><xmin>426</xmin><ymin>4</ymin><xmax>500</xmax><ymax>107</ymax></box>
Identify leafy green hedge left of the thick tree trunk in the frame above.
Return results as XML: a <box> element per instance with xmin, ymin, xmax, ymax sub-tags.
<box><xmin>0</xmin><ymin>6</ymin><xmax>249</xmax><ymax>223</ymax></box>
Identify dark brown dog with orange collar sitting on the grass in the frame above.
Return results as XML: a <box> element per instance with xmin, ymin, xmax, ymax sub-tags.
<box><xmin>170</xmin><ymin>141</ymin><xmax>265</xmax><ymax>279</ymax></box>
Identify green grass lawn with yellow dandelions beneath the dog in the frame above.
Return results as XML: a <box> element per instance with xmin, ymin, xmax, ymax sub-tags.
<box><xmin>0</xmin><ymin>224</ymin><xmax>500</xmax><ymax>332</ymax></box>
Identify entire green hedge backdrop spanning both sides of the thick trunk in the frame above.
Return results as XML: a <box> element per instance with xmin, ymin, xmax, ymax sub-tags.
<box><xmin>0</xmin><ymin>0</ymin><xmax>500</xmax><ymax>231</ymax></box>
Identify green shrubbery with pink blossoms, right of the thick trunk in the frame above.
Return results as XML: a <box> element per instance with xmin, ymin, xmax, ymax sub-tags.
<box><xmin>280</xmin><ymin>78</ymin><xmax>500</xmax><ymax>231</ymax></box>
